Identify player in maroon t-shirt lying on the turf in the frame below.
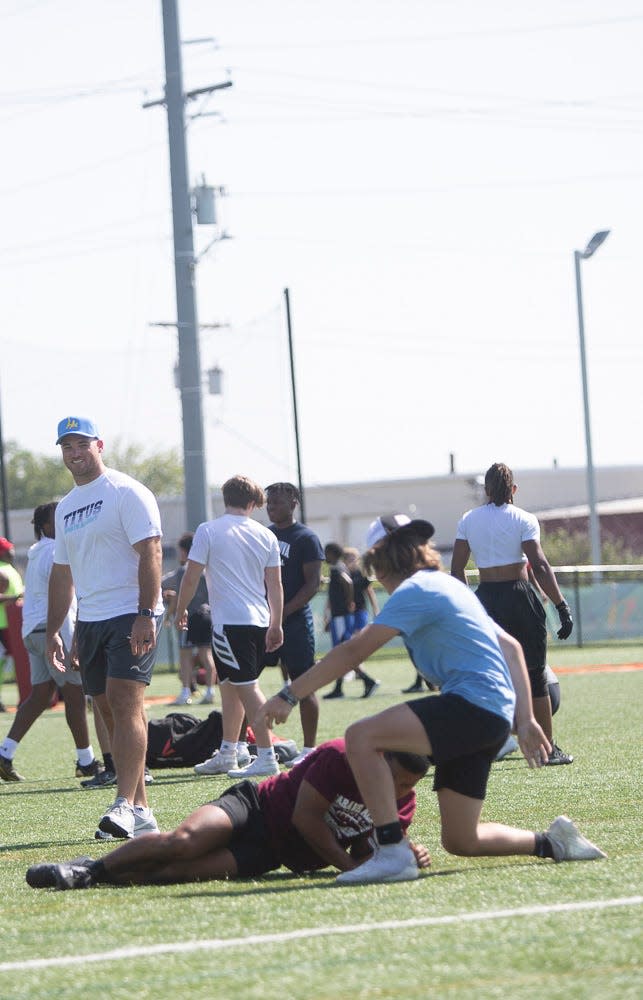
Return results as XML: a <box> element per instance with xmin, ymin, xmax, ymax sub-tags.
<box><xmin>26</xmin><ymin>739</ymin><xmax>431</xmax><ymax>889</ymax></box>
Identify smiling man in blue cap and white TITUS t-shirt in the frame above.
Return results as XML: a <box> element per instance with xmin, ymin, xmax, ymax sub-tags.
<box><xmin>47</xmin><ymin>417</ymin><xmax>163</xmax><ymax>839</ymax></box>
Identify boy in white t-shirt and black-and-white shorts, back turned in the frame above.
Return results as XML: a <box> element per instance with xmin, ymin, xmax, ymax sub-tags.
<box><xmin>175</xmin><ymin>476</ymin><xmax>284</xmax><ymax>778</ymax></box>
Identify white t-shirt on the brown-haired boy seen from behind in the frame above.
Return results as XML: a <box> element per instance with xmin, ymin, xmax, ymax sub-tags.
<box><xmin>189</xmin><ymin>514</ymin><xmax>281</xmax><ymax>628</ymax></box>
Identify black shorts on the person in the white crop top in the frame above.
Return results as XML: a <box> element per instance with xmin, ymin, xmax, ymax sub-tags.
<box><xmin>476</xmin><ymin>580</ymin><xmax>547</xmax><ymax>698</ymax></box>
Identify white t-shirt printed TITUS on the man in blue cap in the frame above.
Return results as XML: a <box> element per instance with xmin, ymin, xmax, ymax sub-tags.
<box><xmin>54</xmin><ymin>469</ymin><xmax>163</xmax><ymax>622</ymax></box>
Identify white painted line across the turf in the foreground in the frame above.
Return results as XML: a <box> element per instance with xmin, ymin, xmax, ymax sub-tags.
<box><xmin>0</xmin><ymin>896</ymin><xmax>643</xmax><ymax>972</ymax></box>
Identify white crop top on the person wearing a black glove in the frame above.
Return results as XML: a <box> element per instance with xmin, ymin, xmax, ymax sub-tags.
<box><xmin>455</xmin><ymin>503</ymin><xmax>540</xmax><ymax>569</ymax></box>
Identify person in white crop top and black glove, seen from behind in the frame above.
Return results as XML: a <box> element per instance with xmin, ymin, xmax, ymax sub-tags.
<box><xmin>451</xmin><ymin>462</ymin><xmax>574</xmax><ymax>766</ymax></box>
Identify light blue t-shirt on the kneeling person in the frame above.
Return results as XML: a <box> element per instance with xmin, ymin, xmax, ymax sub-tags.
<box><xmin>373</xmin><ymin>570</ymin><xmax>516</xmax><ymax>722</ymax></box>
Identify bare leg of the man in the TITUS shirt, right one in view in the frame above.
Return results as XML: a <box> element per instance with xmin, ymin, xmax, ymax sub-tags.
<box><xmin>101</xmin><ymin>677</ymin><xmax>147</xmax><ymax>806</ymax></box>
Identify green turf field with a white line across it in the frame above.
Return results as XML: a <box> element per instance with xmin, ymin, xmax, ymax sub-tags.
<box><xmin>0</xmin><ymin>645</ymin><xmax>643</xmax><ymax>1000</ymax></box>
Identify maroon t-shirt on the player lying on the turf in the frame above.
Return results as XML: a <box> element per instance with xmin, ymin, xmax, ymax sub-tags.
<box><xmin>259</xmin><ymin>739</ymin><xmax>415</xmax><ymax>872</ymax></box>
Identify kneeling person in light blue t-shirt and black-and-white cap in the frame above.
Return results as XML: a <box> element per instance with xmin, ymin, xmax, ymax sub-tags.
<box><xmin>261</xmin><ymin>514</ymin><xmax>605</xmax><ymax>885</ymax></box>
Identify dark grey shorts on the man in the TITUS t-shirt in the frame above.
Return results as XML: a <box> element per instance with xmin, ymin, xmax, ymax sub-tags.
<box><xmin>76</xmin><ymin>614</ymin><xmax>162</xmax><ymax>695</ymax></box>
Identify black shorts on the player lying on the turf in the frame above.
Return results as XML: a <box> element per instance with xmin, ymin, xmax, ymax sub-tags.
<box><xmin>211</xmin><ymin>781</ymin><xmax>281</xmax><ymax>877</ymax></box>
